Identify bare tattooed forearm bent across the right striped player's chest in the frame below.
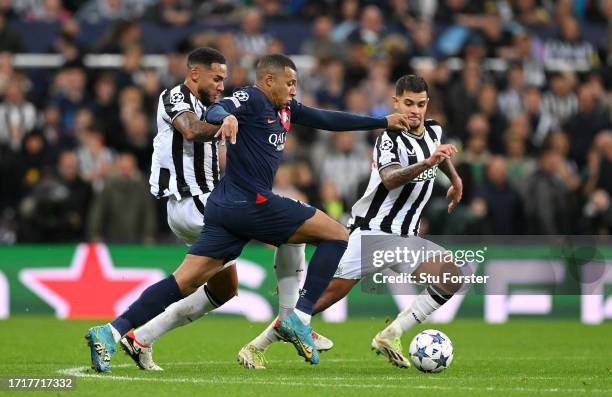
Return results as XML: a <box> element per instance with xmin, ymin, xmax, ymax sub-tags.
<box><xmin>379</xmin><ymin>145</ymin><xmax>457</xmax><ymax>191</ymax></box>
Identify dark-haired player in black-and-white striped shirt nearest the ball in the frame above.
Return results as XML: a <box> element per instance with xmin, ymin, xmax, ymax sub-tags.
<box><xmin>249</xmin><ymin>75</ymin><xmax>463</xmax><ymax>368</ymax></box>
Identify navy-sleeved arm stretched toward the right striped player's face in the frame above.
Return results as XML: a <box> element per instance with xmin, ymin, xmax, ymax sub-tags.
<box><xmin>291</xmin><ymin>103</ymin><xmax>409</xmax><ymax>131</ymax></box>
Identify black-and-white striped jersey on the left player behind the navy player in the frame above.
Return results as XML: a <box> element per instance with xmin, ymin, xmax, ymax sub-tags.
<box><xmin>149</xmin><ymin>84</ymin><xmax>219</xmax><ymax>200</ymax></box>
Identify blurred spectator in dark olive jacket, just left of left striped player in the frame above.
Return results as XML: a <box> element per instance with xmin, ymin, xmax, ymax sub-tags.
<box><xmin>88</xmin><ymin>153</ymin><xmax>157</xmax><ymax>244</ymax></box>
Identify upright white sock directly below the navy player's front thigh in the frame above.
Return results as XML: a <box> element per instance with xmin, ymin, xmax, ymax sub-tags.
<box><xmin>274</xmin><ymin>244</ymin><xmax>306</xmax><ymax>320</ymax></box>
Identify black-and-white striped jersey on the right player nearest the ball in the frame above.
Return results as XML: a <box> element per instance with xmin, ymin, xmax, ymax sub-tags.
<box><xmin>349</xmin><ymin>120</ymin><xmax>442</xmax><ymax>236</ymax></box>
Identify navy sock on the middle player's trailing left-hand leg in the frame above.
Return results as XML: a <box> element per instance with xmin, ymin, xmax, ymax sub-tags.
<box><xmin>111</xmin><ymin>274</ymin><xmax>183</xmax><ymax>336</ymax></box>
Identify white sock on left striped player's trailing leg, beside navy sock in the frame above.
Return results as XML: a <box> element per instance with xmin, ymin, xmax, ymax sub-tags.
<box><xmin>134</xmin><ymin>286</ymin><xmax>218</xmax><ymax>345</ymax></box>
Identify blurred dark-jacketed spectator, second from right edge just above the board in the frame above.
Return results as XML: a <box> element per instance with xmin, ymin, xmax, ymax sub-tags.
<box><xmin>524</xmin><ymin>150</ymin><xmax>571</xmax><ymax>235</ymax></box>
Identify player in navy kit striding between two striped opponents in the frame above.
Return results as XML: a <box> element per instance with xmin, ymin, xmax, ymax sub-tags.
<box><xmin>200</xmin><ymin>54</ymin><xmax>408</xmax><ymax>364</ymax></box>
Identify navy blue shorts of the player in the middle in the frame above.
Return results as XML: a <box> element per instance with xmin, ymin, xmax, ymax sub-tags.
<box><xmin>189</xmin><ymin>194</ymin><xmax>316</xmax><ymax>261</ymax></box>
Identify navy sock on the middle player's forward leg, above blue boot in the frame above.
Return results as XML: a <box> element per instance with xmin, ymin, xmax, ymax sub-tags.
<box><xmin>295</xmin><ymin>240</ymin><xmax>348</xmax><ymax>314</ymax></box>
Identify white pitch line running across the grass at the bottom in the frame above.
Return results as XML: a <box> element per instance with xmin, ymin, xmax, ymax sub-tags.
<box><xmin>57</xmin><ymin>360</ymin><xmax>612</xmax><ymax>393</ymax></box>
